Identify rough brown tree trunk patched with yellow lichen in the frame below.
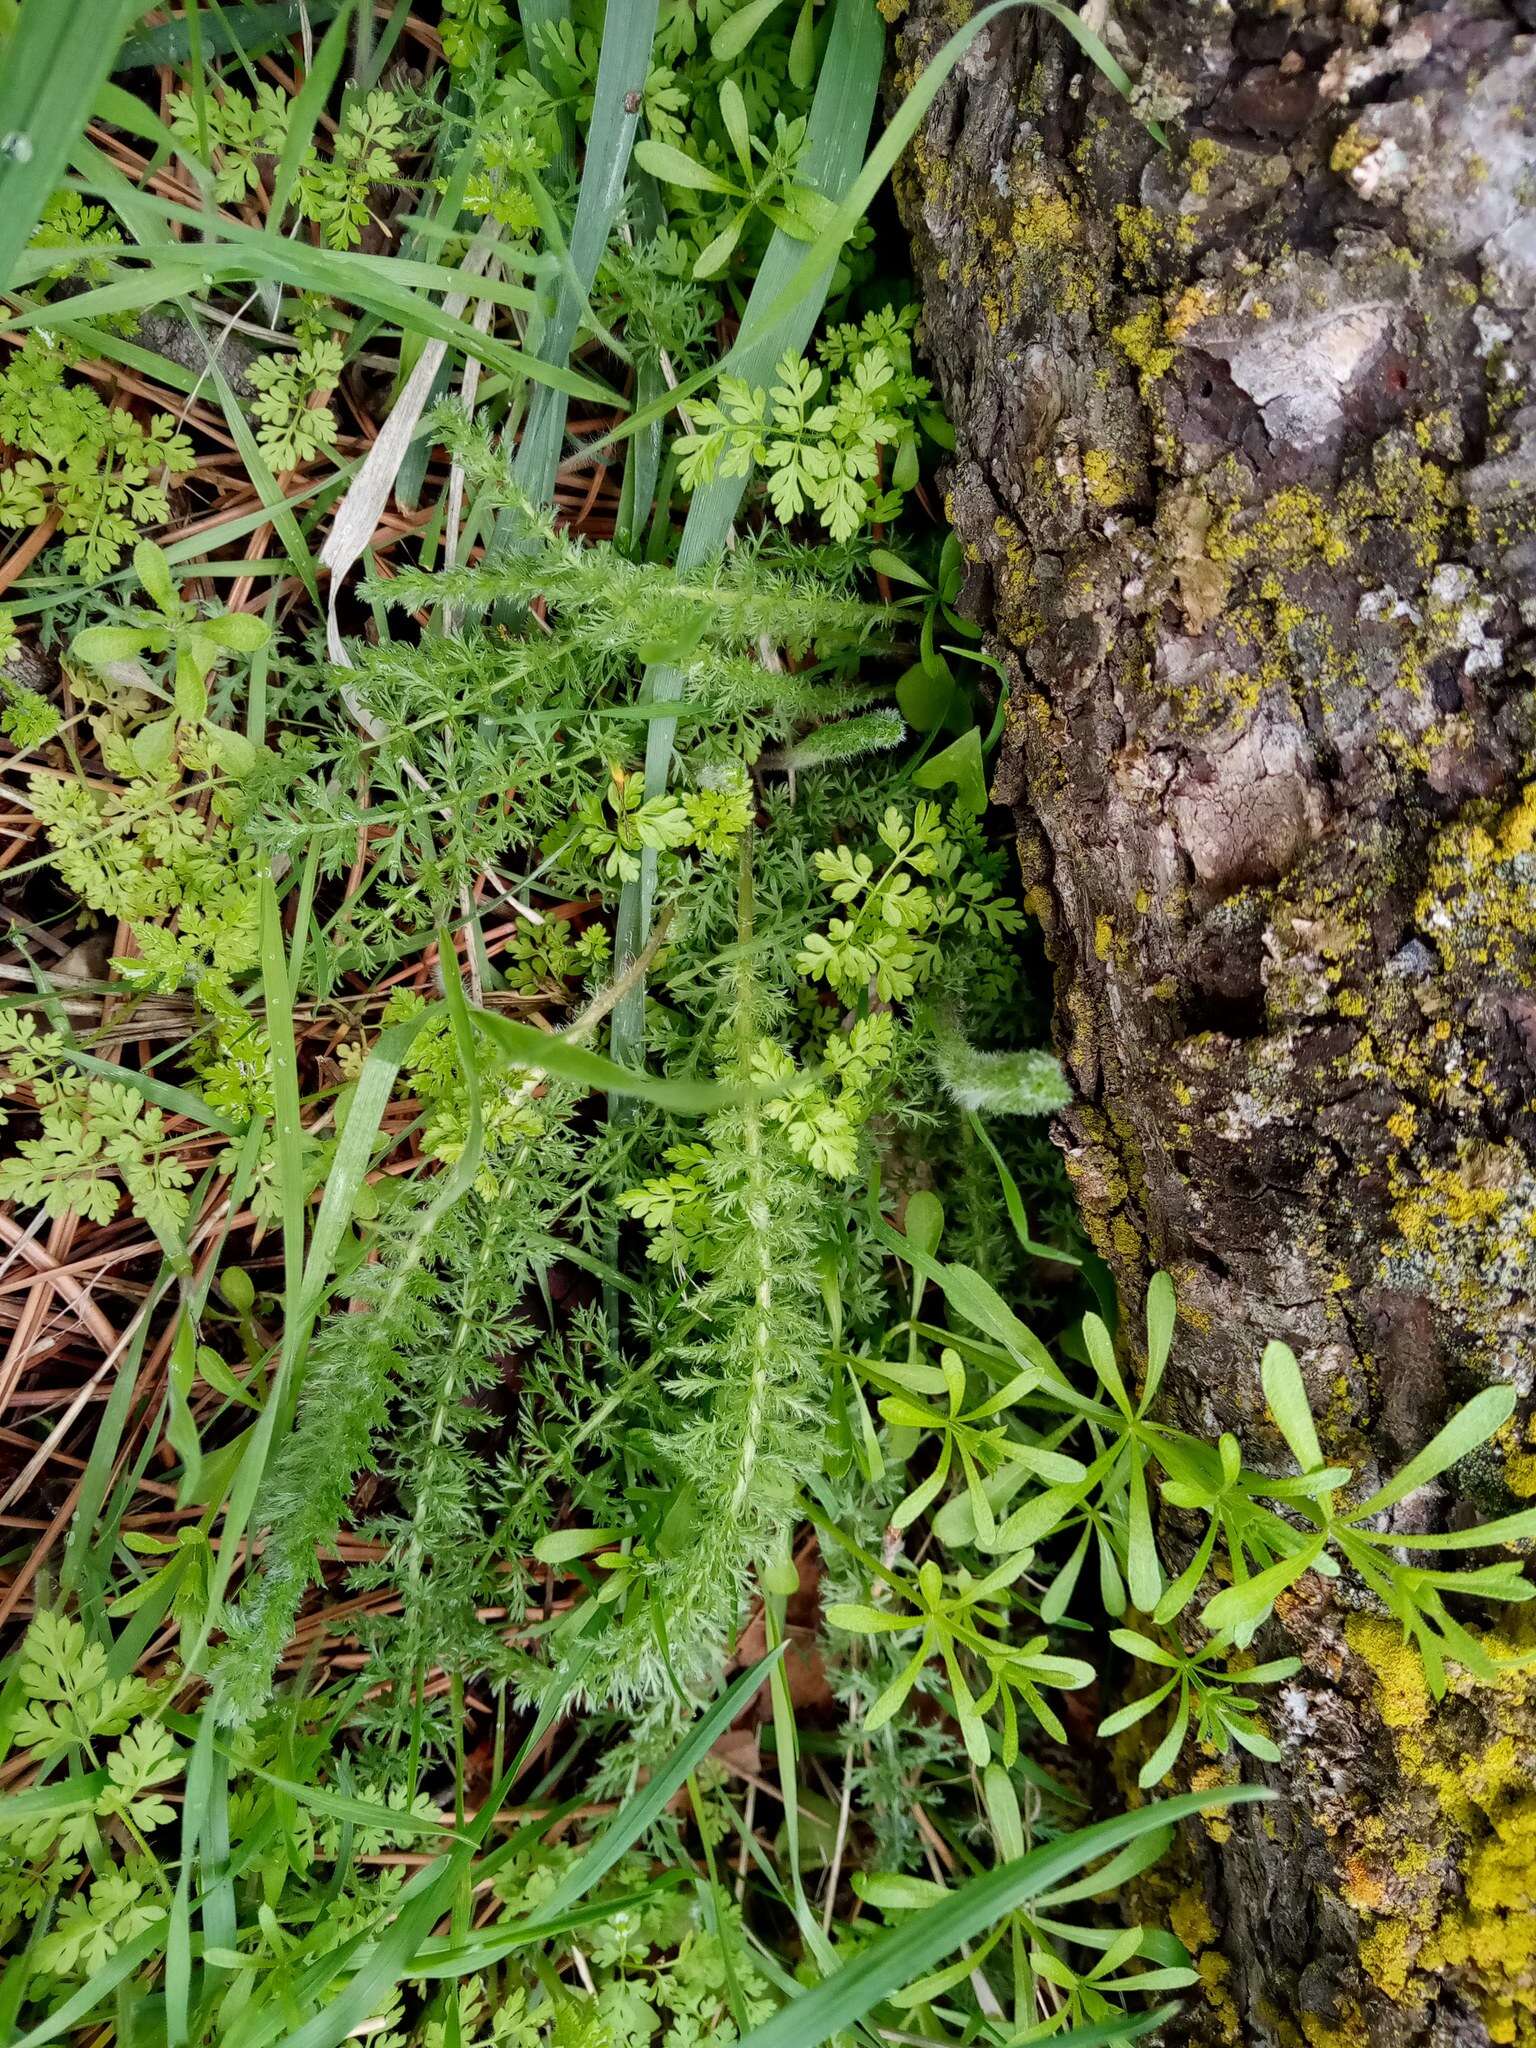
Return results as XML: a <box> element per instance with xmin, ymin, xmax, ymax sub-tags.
<box><xmin>885</xmin><ymin>0</ymin><xmax>1536</xmax><ymax>2048</ymax></box>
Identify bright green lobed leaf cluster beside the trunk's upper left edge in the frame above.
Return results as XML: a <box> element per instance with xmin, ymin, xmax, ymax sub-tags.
<box><xmin>678</xmin><ymin>305</ymin><xmax>932</xmax><ymax>541</ymax></box>
